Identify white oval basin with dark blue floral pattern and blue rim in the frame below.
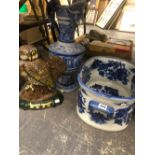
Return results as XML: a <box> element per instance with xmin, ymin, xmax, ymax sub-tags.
<box><xmin>77</xmin><ymin>56</ymin><xmax>135</xmax><ymax>131</ymax></box>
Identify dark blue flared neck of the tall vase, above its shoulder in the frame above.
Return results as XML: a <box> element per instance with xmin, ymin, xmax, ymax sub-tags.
<box><xmin>56</xmin><ymin>1</ymin><xmax>86</xmax><ymax>43</ymax></box>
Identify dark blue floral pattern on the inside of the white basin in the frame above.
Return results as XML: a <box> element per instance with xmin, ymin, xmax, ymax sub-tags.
<box><xmin>78</xmin><ymin>58</ymin><xmax>135</xmax><ymax>98</ymax></box>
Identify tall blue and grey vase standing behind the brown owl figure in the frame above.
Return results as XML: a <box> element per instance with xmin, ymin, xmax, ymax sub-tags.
<box><xmin>49</xmin><ymin>0</ymin><xmax>86</xmax><ymax>92</ymax></box>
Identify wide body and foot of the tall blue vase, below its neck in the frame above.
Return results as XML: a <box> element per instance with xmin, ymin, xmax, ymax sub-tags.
<box><xmin>49</xmin><ymin>42</ymin><xmax>85</xmax><ymax>92</ymax></box>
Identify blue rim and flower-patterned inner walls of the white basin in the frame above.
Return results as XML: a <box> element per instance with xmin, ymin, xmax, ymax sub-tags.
<box><xmin>77</xmin><ymin>57</ymin><xmax>135</xmax><ymax>102</ymax></box>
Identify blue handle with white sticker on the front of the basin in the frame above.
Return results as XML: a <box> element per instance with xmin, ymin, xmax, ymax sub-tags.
<box><xmin>88</xmin><ymin>100</ymin><xmax>114</xmax><ymax>117</ymax></box>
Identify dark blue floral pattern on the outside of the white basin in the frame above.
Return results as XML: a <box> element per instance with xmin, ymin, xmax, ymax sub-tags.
<box><xmin>78</xmin><ymin>92</ymin><xmax>134</xmax><ymax>126</ymax></box>
